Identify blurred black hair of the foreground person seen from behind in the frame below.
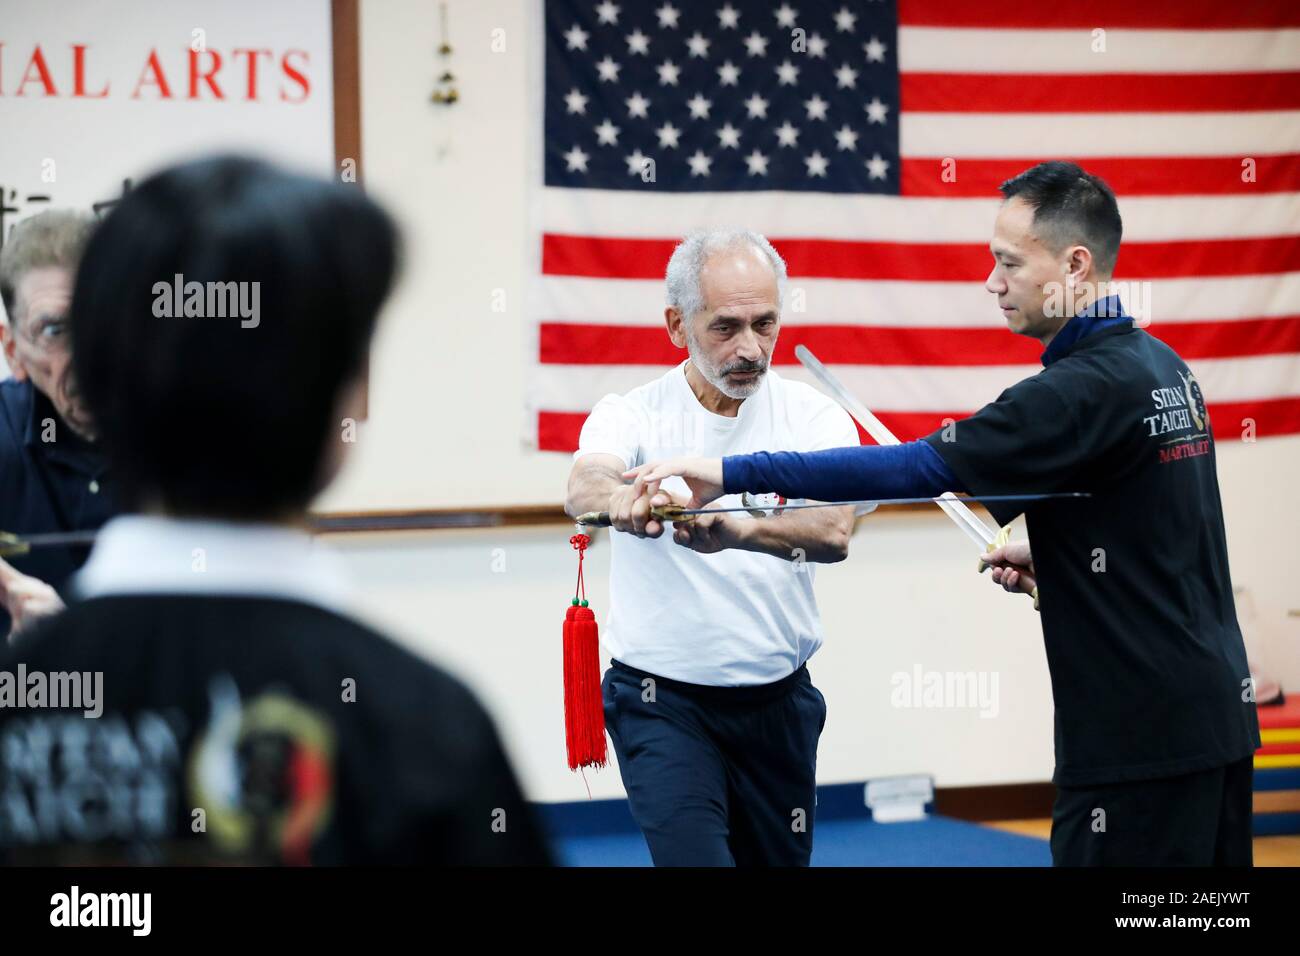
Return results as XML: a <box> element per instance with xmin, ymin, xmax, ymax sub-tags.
<box><xmin>69</xmin><ymin>156</ymin><xmax>398</xmax><ymax>520</ymax></box>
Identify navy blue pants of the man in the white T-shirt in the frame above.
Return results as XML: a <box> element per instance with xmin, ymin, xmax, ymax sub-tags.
<box><xmin>603</xmin><ymin>661</ymin><xmax>826</xmax><ymax>866</ymax></box>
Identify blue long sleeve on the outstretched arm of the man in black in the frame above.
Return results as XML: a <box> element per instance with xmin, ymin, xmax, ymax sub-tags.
<box><xmin>723</xmin><ymin>441</ymin><xmax>966</xmax><ymax>501</ymax></box>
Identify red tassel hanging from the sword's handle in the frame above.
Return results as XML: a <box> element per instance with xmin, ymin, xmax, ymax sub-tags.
<box><xmin>564</xmin><ymin>535</ymin><xmax>606</xmax><ymax>770</ymax></box>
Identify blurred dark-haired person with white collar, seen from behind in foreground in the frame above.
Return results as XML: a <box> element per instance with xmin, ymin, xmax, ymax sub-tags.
<box><xmin>0</xmin><ymin>159</ymin><xmax>549</xmax><ymax>865</ymax></box>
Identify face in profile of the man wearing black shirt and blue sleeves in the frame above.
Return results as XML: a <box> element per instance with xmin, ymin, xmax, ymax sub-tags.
<box><xmin>984</xmin><ymin>196</ymin><xmax>1074</xmax><ymax>341</ymax></box>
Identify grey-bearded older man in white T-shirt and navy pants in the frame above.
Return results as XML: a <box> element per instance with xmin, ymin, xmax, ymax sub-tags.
<box><xmin>567</xmin><ymin>230</ymin><xmax>858</xmax><ymax>866</ymax></box>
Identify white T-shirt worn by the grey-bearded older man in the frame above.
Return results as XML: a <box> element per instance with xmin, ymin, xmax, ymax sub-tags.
<box><xmin>573</xmin><ymin>362</ymin><xmax>858</xmax><ymax>687</ymax></box>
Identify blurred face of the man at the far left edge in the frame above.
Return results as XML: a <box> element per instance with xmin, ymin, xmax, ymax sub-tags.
<box><xmin>0</xmin><ymin>267</ymin><xmax>91</xmax><ymax>436</ymax></box>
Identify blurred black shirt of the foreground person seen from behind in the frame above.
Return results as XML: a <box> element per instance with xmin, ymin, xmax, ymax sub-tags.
<box><xmin>0</xmin><ymin>594</ymin><xmax>550</xmax><ymax>865</ymax></box>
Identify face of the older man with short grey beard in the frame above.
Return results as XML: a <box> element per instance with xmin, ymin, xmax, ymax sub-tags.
<box><xmin>668</xmin><ymin>247</ymin><xmax>781</xmax><ymax>399</ymax></box>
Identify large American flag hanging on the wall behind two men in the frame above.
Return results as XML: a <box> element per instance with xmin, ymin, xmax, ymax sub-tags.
<box><xmin>527</xmin><ymin>0</ymin><xmax>1300</xmax><ymax>451</ymax></box>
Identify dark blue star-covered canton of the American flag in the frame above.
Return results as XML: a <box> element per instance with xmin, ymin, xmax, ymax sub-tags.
<box><xmin>546</xmin><ymin>0</ymin><xmax>900</xmax><ymax>195</ymax></box>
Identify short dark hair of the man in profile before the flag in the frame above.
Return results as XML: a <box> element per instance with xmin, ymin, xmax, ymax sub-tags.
<box><xmin>998</xmin><ymin>160</ymin><xmax>1123</xmax><ymax>276</ymax></box>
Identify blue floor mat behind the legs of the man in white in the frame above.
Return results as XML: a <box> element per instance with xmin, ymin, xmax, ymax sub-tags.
<box><xmin>554</xmin><ymin>817</ymin><xmax>1052</xmax><ymax>866</ymax></box>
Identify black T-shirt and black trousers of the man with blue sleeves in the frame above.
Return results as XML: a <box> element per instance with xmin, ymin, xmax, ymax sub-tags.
<box><xmin>926</xmin><ymin>300</ymin><xmax>1260</xmax><ymax>865</ymax></box>
